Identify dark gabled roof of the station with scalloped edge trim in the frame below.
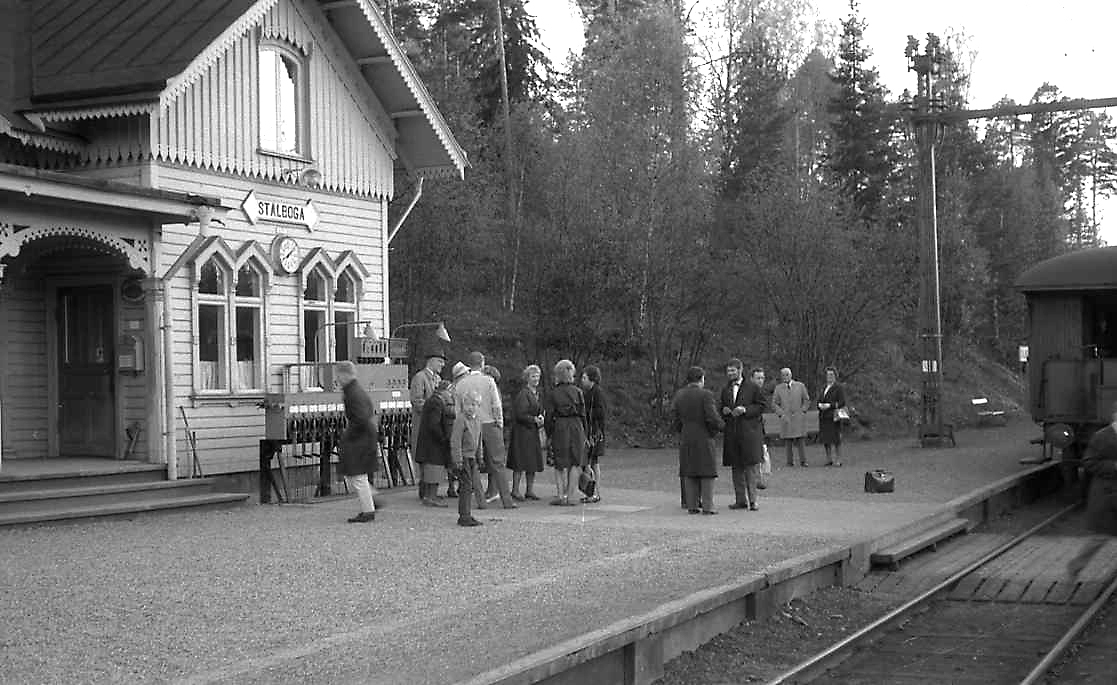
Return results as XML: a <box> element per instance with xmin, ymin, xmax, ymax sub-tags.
<box><xmin>12</xmin><ymin>0</ymin><xmax>468</xmax><ymax>178</ymax></box>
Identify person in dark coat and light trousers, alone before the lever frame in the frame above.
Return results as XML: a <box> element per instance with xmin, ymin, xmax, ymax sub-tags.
<box><xmin>336</xmin><ymin>362</ymin><xmax>380</xmax><ymax>523</ymax></box>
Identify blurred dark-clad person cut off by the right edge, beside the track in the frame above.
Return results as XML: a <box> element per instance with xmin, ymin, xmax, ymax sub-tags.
<box><xmin>1067</xmin><ymin>402</ymin><xmax>1117</xmax><ymax>578</ymax></box>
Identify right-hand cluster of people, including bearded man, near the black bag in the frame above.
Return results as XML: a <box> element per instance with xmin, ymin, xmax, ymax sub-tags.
<box><xmin>671</xmin><ymin>359</ymin><xmax>846</xmax><ymax>515</ymax></box>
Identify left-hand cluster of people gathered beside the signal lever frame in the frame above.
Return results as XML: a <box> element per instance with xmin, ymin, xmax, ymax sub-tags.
<box><xmin>402</xmin><ymin>352</ymin><xmax>605</xmax><ymax>527</ymax></box>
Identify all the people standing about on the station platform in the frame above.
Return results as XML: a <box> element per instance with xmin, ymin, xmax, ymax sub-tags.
<box><xmin>337</xmin><ymin>352</ymin><xmax>846</xmax><ymax>527</ymax></box>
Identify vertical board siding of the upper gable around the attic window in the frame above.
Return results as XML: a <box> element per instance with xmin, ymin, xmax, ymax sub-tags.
<box><xmin>153</xmin><ymin>0</ymin><xmax>395</xmax><ymax>197</ymax></box>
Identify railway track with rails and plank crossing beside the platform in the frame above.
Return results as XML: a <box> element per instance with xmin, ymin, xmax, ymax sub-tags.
<box><xmin>768</xmin><ymin>505</ymin><xmax>1117</xmax><ymax>685</ymax></box>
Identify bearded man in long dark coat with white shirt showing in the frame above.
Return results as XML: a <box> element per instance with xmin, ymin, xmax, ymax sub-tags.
<box><xmin>719</xmin><ymin>359</ymin><xmax>765</xmax><ymax>512</ymax></box>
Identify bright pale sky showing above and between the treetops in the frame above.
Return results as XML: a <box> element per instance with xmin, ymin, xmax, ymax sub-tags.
<box><xmin>527</xmin><ymin>0</ymin><xmax>1117</xmax><ymax>245</ymax></box>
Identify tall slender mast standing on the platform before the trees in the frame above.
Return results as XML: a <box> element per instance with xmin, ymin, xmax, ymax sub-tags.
<box><xmin>907</xmin><ymin>37</ymin><xmax>953</xmax><ymax>447</ymax></box>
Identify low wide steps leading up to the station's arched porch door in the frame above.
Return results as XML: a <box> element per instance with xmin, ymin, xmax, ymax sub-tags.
<box><xmin>0</xmin><ymin>466</ymin><xmax>248</xmax><ymax>526</ymax></box>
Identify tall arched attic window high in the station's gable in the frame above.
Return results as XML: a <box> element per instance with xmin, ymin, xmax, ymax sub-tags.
<box><xmin>259</xmin><ymin>45</ymin><xmax>306</xmax><ymax>155</ymax></box>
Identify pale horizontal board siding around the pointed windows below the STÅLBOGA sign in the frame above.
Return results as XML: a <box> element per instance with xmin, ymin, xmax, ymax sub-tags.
<box><xmin>155</xmin><ymin>165</ymin><xmax>384</xmax><ymax>476</ymax></box>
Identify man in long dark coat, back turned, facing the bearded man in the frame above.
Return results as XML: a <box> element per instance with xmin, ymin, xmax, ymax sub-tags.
<box><xmin>671</xmin><ymin>367</ymin><xmax>725</xmax><ymax>514</ymax></box>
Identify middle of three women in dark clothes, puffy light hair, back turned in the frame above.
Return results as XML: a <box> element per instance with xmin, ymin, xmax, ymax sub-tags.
<box><xmin>543</xmin><ymin>359</ymin><xmax>585</xmax><ymax>506</ymax></box>
